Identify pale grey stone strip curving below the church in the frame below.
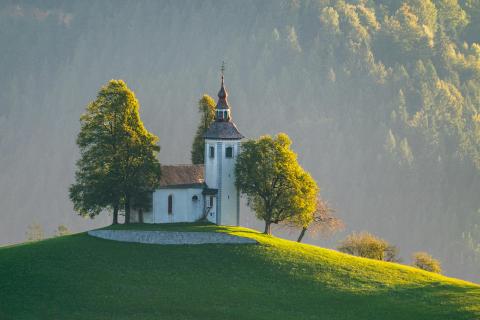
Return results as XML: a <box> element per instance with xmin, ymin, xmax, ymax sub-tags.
<box><xmin>88</xmin><ymin>230</ymin><xmax>257</xmax><ymax>244</ymax></box>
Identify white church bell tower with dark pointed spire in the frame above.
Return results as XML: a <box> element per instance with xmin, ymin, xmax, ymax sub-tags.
<box><xmin>204</xmin><ymin>64</ymin><xmax>244</xmax><ymax>225</ymax></box>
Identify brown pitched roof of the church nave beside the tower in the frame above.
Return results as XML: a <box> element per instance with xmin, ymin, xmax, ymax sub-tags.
<box><xmin>160</xmin><ymin>164</ymin><xmax>205</xmax><ymax>188</ymax></box>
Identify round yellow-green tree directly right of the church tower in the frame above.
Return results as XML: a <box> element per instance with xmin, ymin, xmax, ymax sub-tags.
<box><xmin>235</xmin><ymin>133</ymin><xmax>318</xmax><ymax>234</ymax></box>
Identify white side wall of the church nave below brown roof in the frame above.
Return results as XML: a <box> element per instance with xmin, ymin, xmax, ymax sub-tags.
<box><xmin>153</xmin><ymin>187</ymin><xmax>203</xmax><ymax>223</ymax></box>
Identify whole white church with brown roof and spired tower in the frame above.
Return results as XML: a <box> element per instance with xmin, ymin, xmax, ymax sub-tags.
<box><xmin>132</xmin><ymin>74</ymin><xmax>244</xmax><ymax>225</ymax></box>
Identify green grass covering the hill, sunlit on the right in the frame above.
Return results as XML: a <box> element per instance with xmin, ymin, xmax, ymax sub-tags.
<box><xmin>0</xmin><ymin>224</ymin><xmax>480</xmax><ymax>320</ymax></box>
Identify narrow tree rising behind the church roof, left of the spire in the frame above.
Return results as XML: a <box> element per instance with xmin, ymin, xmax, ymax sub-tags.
<box><xmin>191</xmin><ymin>94</ymin><xmax>215</xmax><ymax>164</ymax></box>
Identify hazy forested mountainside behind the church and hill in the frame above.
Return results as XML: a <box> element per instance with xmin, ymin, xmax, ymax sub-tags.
<box><xmin>0</xmin><ymin>0</ymin><xmax>480</xmax><ymax>281</ymax></box>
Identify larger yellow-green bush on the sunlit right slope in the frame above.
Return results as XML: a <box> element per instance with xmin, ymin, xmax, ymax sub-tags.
<box><xmin>338</xmin><ymin>232</ymin><xmax>397</xmax><ymax>261</ymax></box>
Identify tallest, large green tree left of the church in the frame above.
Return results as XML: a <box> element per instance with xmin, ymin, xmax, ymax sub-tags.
<box><xmin>70</xmin><ymin>80</ymin><xmax>160</xmax><ymax>224</ymax></box>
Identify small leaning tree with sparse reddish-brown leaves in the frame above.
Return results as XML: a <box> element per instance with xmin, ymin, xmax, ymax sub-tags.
<box><xmin>288</xmin><ymin>197</ymin><xmax>344</xmax><ymax>242</ymax></box>
